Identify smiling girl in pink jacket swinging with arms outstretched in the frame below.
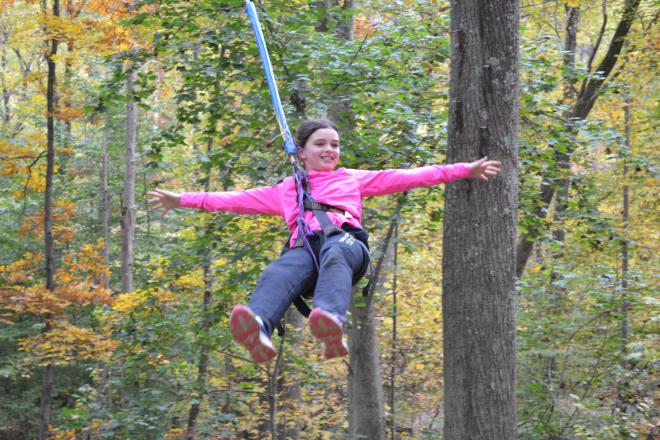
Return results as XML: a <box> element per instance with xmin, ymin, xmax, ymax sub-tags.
<box><xmin>149</xmin><ymin>119</ymin><xmax>501</xmax><ymax>362</ymax></box>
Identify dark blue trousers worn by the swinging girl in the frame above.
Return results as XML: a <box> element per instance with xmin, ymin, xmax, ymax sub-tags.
<box><xmin>248</xmin><ymin>232</ymin><xmax>369</xmax><ymax>334</ymax></box>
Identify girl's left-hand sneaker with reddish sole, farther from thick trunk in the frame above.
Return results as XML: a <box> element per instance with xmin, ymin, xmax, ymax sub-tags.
<box><xmin>229</xmin><ymin>304</ymin><xmax>277</xmax><ymax>363</ymax></box>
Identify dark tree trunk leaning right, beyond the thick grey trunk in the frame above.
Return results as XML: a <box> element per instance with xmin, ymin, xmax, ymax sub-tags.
<box><xmin>516</xmin><ymin>0</ymin><xmax>640</xmax><ymax>277</ymax></box>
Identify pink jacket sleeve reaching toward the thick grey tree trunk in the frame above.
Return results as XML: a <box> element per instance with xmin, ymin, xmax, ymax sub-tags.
<box><xmin>351</xmin><ymin>162</ymin><xmax>471</xmax><ymax>197</ymax></box>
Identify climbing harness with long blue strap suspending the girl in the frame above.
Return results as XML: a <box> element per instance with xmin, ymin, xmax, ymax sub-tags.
<box><xmin>245</xmin><ymin>0</ymin><xmax>371</xmax><ymax>324</ymax></box>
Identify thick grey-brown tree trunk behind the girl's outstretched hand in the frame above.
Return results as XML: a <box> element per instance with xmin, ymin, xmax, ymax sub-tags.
<box><xmin>442</xmin><ymin>0</ymin><xmax>519</xmax><ymax>440</ymax></box>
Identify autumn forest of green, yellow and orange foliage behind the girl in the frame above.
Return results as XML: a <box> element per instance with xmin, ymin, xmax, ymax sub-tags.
<box><xmin>0</xmin><ymin>0</ymin><xmax>660</xmax><ymax>439</ymax></box>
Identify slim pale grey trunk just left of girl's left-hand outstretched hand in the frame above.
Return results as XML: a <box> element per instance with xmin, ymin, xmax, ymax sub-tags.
<box><xmin>121</xmin><ymin>64</ymin><xmax>137</xmax><ymax>293</ymax></box>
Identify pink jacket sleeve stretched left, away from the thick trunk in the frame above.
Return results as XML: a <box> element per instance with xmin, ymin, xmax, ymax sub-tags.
<box><xmin>179</xmin><ymin>185</ymin><xmax>284</xmax><ymax>216</ymax></box>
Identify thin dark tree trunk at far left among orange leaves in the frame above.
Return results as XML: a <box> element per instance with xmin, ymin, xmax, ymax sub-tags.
<box><xmin>39</xmin><ymin>0</ymin><xmax>60</xmax><ymax>440</ymax></box>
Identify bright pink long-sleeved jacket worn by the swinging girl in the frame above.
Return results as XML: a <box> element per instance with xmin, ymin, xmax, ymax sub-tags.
<box><xmin>179</xmin><ymin>163</ymin><xmax>470</xmax><ymax>246</ymax></box>
